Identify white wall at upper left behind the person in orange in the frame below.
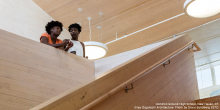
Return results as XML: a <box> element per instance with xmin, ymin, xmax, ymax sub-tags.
<box><xmin>0</xmin><ymin>0</ymin><xmax>70</xmax><ymax>42</ymax></box>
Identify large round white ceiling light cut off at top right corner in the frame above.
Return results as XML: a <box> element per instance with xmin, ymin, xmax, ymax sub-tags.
<box><xmin>184</xmin><ymin>0</ymin><xmax>220</xmax><ymax>18</ymax></box>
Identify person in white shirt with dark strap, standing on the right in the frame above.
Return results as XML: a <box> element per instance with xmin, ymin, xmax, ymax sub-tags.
<box><xmin>66</xmin><ymin>23</ymin><xmax>88</xmax><ymax>58</ymax></box>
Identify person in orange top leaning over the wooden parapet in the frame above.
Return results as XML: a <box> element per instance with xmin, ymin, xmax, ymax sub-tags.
<box><xmin>40</xmin><ymin>21</ymin><xmax>73</xmax><ymax>51</ymax></box>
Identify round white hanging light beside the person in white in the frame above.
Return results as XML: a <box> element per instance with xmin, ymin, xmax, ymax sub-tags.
<box><xmin>83</xmin><ymin>41</ymin><xmax>108</xmax><ymax>60</ymax></box>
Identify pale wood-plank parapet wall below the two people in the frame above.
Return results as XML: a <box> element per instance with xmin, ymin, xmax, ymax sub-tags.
<box><xmin>0</xmin><ymin>30</ymin><xmax>95</xmax><ymax>110</ymax></box>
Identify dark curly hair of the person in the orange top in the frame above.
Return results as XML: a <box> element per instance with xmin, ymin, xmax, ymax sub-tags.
<box><xmin>45</xmin><ymin>20</ymin><xmax>63</xmax><ymax>35</ymax></box>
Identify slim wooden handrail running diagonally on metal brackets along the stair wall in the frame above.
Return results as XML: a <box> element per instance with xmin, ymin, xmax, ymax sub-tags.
<box><xmin>80</xmin><ymin>41</ymin><xmax>194</xmax><ymax>110</ymax></box>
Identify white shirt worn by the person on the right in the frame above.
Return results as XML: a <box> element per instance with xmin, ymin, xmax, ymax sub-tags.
<box><xmin>68</xmin><ymin>40</ymin><xmax>83</xmax><ymax>57</ymax></box>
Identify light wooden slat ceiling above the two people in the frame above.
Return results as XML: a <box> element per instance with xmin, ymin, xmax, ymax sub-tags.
<box><xmin>33</xmin><ymin>0</ymin><xmax>220</xmax><ymax>56</ymax></box>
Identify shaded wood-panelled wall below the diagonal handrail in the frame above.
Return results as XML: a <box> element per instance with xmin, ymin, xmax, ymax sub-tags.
<box><xmin>93</xmin><ymin>50</ymin><xmax>199</xmax><ymax>110</ymax></box>
